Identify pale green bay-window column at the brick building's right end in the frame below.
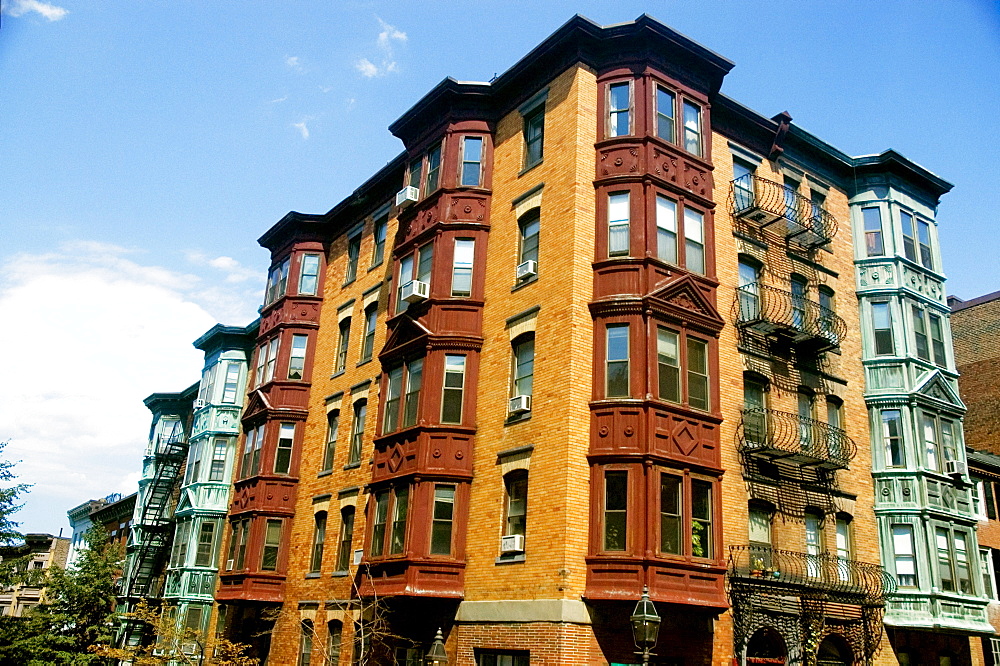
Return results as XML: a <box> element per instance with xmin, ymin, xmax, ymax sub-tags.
<box><xmin>851</xmin><ymin>151</ymin><xmax>993</xmax><ymax>652</ymax></box>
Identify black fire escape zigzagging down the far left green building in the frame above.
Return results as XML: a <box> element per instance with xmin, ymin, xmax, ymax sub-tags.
<box><xmin>118</xmin><ymin>421</ymin><xmax>187</xmax><ymax>647</ymax></box>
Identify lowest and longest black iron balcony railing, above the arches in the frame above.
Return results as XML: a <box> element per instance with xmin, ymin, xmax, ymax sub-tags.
<box><xmin>728</xmin><ymin>545</ymin><xmax>896</xmax><ymax>606</ymax></box>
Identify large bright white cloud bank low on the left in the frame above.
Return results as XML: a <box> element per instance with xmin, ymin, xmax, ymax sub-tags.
<box><xmin>0</xmin><ymin>242</ymin><xmax>260</xmax><ymax>531</ymax></box>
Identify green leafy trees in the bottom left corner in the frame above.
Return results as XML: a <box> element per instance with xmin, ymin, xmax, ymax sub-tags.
<box><xmin>0</xmin><ymin>527</ymin><xmax>122</xmax><ymax>666</ymax></box>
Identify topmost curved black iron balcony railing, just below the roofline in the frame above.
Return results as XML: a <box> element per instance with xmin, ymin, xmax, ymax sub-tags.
<box><xmin>730</xmin><ymin>173</ymin><xmax>839</xmax><ymax>247</ymax></box>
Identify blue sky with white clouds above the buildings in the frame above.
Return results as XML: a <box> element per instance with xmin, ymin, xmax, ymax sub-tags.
<box><xmin>0</xmin><ymin>0</ymin><xmax>1000</xmax><ymax>534</ymax></box>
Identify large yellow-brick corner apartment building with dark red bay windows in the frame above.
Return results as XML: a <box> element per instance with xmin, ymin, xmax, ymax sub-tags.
<box><xmin>174</xmin><ymin>16</ymin><xmax>988</xmax><ymax>665</ymax></box>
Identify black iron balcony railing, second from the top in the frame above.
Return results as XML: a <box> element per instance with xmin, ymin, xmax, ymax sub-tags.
<box><xmin>735</xmin><ymin>282</ymin><xmax>847</xmax><ymax>352</ymax></box>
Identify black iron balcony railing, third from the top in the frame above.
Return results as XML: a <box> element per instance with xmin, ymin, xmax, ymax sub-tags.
<box><xmin>736</xmin><ymin>408</ymin><xmax>858</xmax><ymax>469</ymax></box>
